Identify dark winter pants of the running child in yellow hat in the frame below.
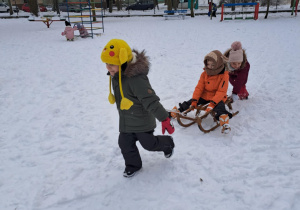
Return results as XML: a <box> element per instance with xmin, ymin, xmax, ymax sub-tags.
<box><xmin>119</xmin><ymin>131</ymin><xmax>174</xmax><ymax>171</ymax></box>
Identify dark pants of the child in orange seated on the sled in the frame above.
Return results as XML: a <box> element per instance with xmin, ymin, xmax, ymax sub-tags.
<box><xmin>179</xmin><ymin>98</ymin><xmax>232</xmax><ymax>120</ymax></box>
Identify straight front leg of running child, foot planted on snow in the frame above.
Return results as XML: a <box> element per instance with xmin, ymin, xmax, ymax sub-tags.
<box><xmin>119</xmin><ymin>133</ymin><xmax>142</xmax><ymax>172</ymax></box>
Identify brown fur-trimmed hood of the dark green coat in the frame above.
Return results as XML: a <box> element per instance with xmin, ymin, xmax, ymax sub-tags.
<box><xmin>124</xmin><ymin>49</ymin><xmax>150</xmax><ymax>77</ymax></box>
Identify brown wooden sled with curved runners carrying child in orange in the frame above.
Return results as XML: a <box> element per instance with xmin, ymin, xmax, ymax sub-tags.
<box><xmin>176</xmin><ymin>99</ymin><xmax>239</xmax><ymax>133</ymax></box>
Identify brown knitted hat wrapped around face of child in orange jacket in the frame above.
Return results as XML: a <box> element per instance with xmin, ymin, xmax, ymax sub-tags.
<box><xmin>204</xmin><ymin>50</ymin><xmax>225</xmax><ymax>76</ymax></box>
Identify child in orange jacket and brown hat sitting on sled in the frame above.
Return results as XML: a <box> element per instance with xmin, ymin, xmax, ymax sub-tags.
<box><xmin>171</xmin><ymin>50</ymin><xmax>232</xmax><ymax>133</ymax></box>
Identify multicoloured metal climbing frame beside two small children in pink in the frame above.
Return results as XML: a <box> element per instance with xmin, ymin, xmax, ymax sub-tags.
<box><xmin>66</xmin><ymin>0</ymin><xmax>104</xmax><ymax>38</ymax></box>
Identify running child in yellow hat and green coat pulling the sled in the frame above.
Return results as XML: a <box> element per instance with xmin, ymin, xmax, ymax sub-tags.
<box><xmin>101</xmin><ymin>39</ymin><xmax>175</xmax><ymax>178</ymax></box>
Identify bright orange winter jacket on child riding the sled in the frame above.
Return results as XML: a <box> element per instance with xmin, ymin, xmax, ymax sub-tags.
<box><xmin>193</xmin><ymin>70</ymin><xmax>229</xmax><ymax>104</ymax></box>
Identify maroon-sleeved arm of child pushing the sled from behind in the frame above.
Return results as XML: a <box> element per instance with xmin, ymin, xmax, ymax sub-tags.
<box><xmin>230</xmin><ymin>62</ymin><xmax>250</xmax><ymax>94</ymax></box>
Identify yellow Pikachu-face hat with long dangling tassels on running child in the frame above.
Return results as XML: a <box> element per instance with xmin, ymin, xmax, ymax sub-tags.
<box><xmin>101</xmin><ymin>39</ymin><xmax>133</xmax><ymax>110</ymax></box>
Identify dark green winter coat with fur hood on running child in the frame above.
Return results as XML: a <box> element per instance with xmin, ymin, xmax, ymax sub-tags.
<box><xmin>112</xmin><ymin>50</ymin><xmax>168</xmax><ymax>133</ymax></box>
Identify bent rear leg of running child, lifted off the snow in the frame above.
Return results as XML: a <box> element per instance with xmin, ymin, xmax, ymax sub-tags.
<box><xmin>136</xmin><ymin>131</ymin><xmax>175</xmax><ymax>157</ymax></box>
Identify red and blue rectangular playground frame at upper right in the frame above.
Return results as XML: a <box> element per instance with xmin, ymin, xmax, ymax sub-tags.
<box><xmin>220</xmin><ymin>2</ymin><xmax>259</xmax><ymax>21</ymax></box>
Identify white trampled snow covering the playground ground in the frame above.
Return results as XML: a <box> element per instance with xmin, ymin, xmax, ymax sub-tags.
<box><xmin>0</xmin><ymin>6</ymin><xmax>300</xmax><ymax>210</ymax></box>
